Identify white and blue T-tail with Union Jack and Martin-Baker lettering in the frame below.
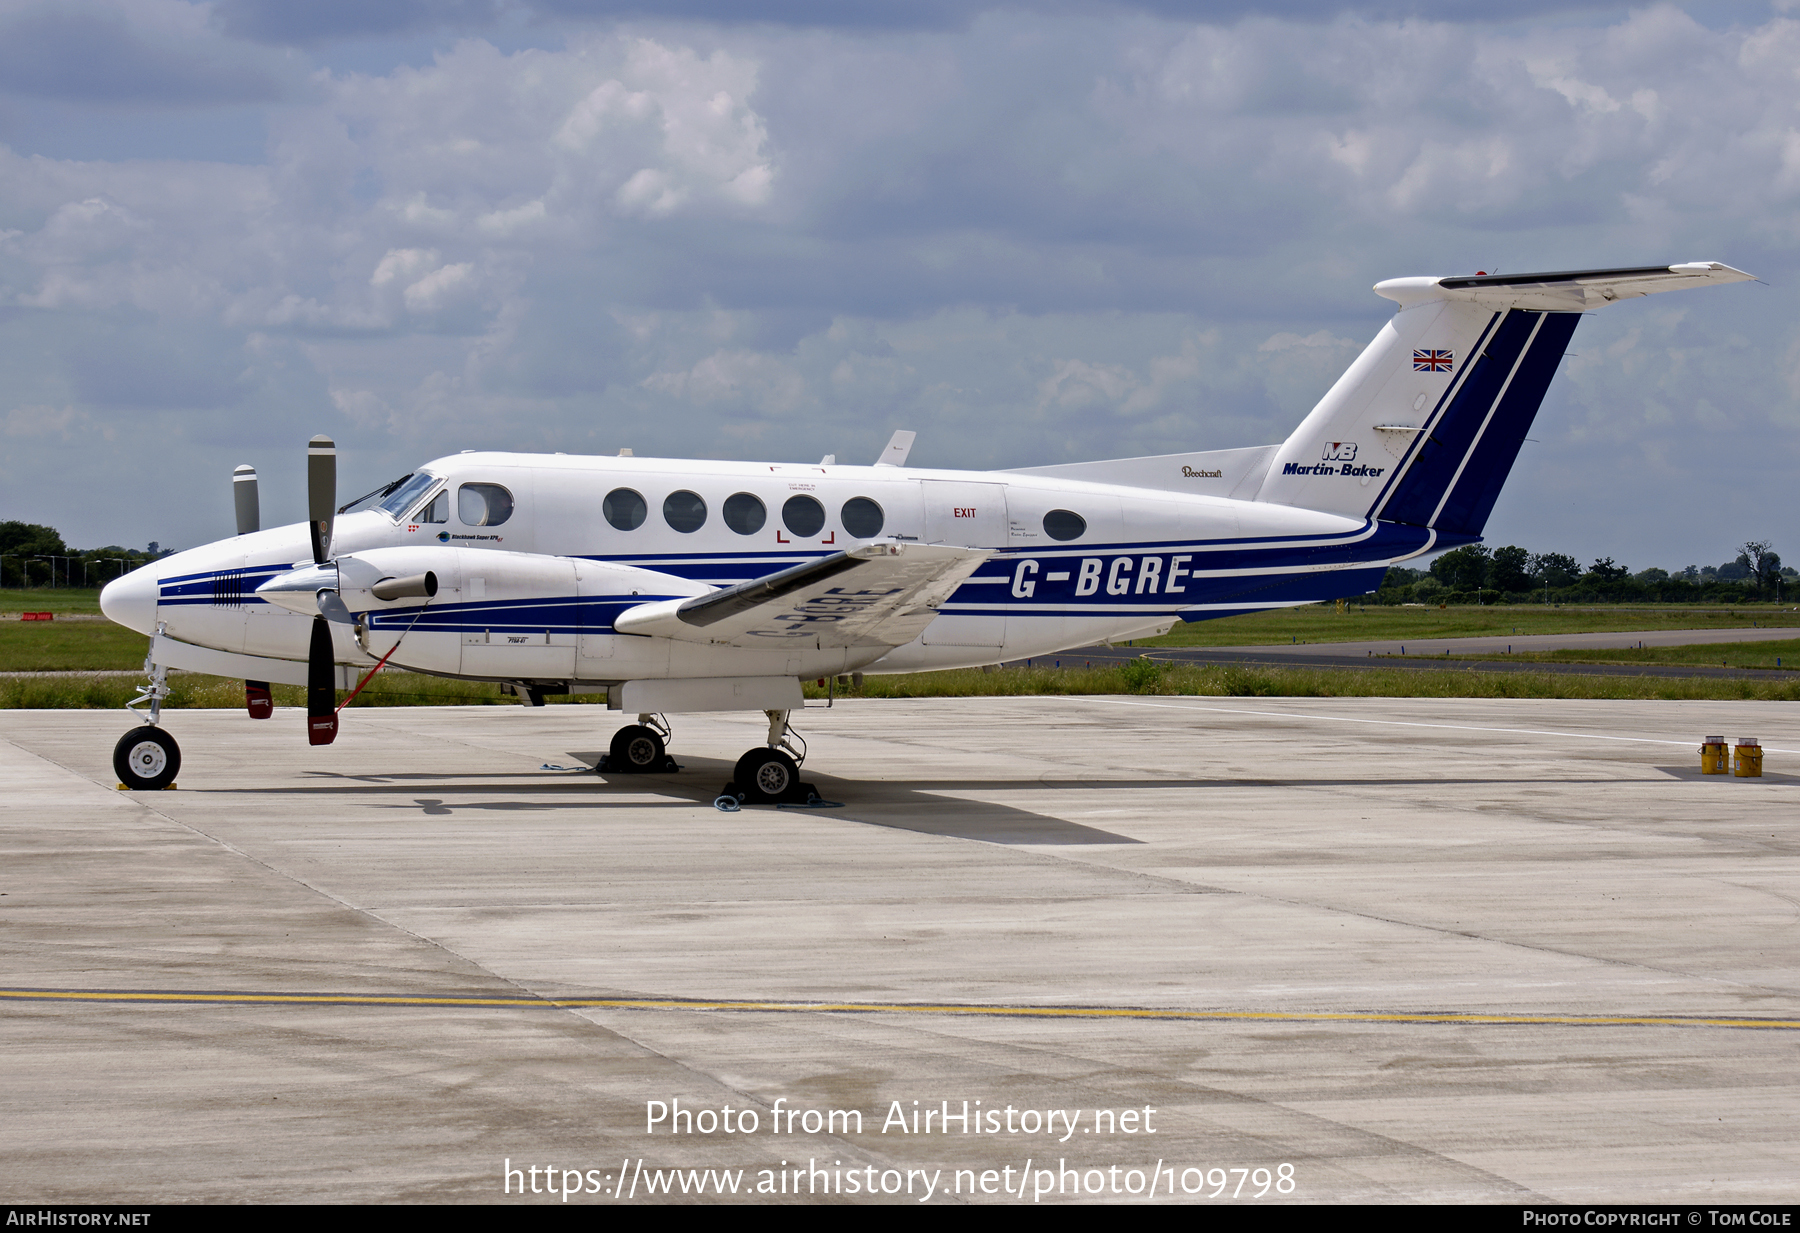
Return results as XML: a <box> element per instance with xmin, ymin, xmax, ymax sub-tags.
<box><xmin>1256</xmin><ymin>263</ymin><xmax>1751</xmax><ymax>536</ymax></box>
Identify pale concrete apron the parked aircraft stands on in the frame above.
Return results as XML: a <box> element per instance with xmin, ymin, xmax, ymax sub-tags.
<box><xmin>0</xmin><ymin>697</ymin><xmax>1800</xmax><ymax>1202</ymax></box>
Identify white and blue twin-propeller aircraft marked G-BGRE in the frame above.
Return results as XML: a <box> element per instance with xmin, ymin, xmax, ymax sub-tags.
<box><xmin>101</xmin><ymin>261</ymin><xmax>1751</xmax><ymax>808</ymax></box>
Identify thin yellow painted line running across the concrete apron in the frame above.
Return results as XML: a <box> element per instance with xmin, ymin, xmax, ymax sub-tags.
<box><xmin>0</xmin><ymin>988</ymin><xmax>1800</xmax><ymax>1031</ymax></box>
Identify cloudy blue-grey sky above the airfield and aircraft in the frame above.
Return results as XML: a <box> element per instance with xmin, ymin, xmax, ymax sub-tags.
<box><xmin>0</xmin><ymin>0</ymin><xmax>1800</xmax><ymax>569</ymax></box>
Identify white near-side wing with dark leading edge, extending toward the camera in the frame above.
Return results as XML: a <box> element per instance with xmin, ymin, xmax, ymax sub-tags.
<box><xmin>612</xmin><ymin>544</ymin><xmax>994</xmax><ymax>650</ymax></box>
